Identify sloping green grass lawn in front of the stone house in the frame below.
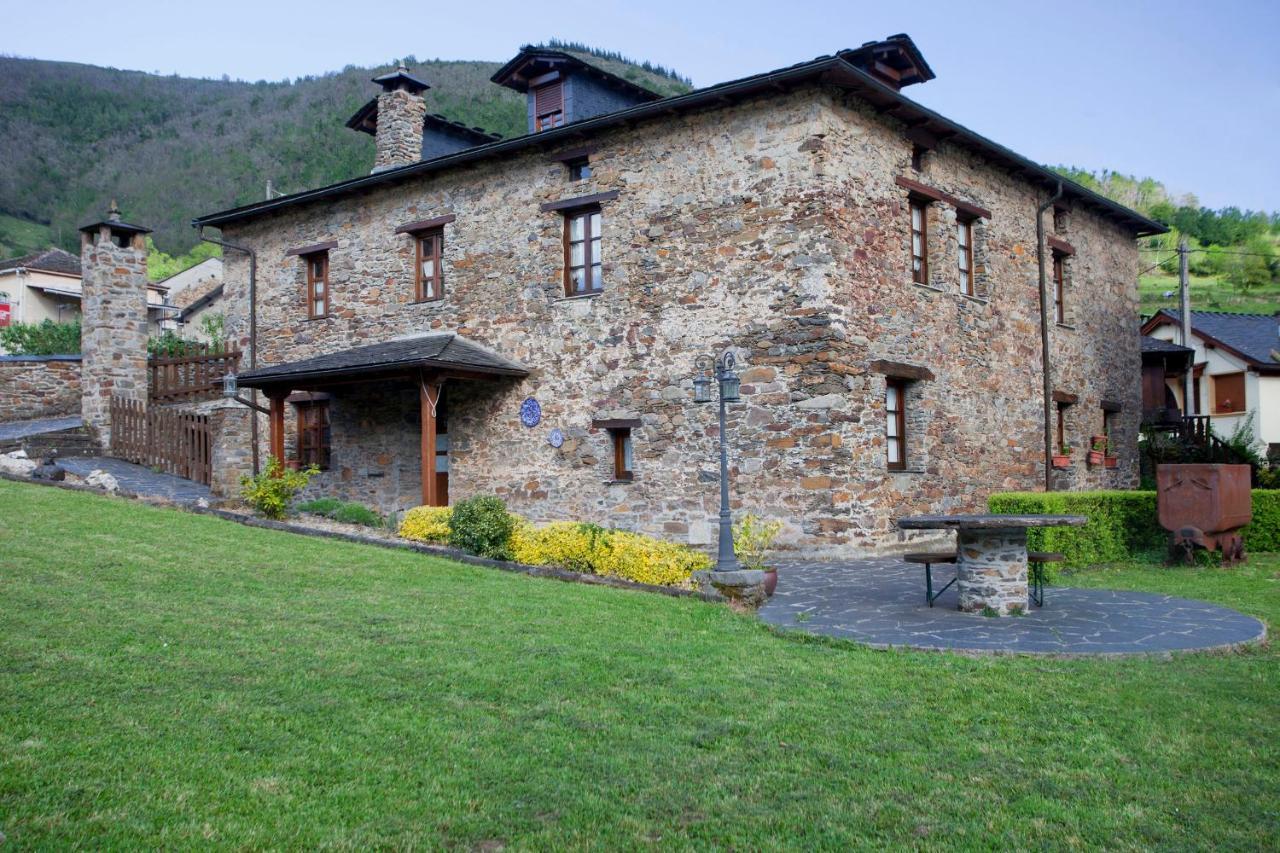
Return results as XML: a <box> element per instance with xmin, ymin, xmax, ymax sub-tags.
<box><xmin>0</xmin><ymin>480</ymin><xmax>1280</xmax><ymax>849</ymax></box>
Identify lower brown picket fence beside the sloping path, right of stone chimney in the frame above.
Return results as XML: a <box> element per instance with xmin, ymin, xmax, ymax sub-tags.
<box><xmin>111</xmin><ymin>397</ymin><xmax>212</xmax><ymax>485</ymax></box>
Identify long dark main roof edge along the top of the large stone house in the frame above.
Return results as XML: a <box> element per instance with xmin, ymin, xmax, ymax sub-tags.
<box><xmin>192</xmin><ymin>50</ymin><xmax>1169</xmax><ymax>236</ymax></box>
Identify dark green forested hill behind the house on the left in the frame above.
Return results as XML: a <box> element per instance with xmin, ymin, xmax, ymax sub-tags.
<box><xmin>0</xmin><ymin>44</ymin><xmax>689</xmax><ymax>256</ymax></box>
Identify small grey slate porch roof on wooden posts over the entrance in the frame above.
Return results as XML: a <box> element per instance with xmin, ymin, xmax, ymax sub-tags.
<box><xmin>237</xmin><ymin>332</ymin><xmax>529</xmax><ymax>388</ymax></box>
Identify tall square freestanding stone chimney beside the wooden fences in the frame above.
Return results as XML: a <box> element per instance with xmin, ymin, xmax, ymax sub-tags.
<box><xmin>79</xmin><ymin>200</ymin><xmax>151</xmax><ymax>448</ymax></box>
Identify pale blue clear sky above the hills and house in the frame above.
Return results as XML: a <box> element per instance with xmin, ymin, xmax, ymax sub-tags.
<box><xmin>0</xmin><ymin>0</ymin><xmax>1280</xmax><ymax>210</ymax></box>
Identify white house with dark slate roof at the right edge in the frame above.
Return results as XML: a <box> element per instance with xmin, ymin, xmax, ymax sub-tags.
<box><xmin>1142</xmin><ymin>309</ymin><xmax>1280</xmax><ymax>453</ymax></box>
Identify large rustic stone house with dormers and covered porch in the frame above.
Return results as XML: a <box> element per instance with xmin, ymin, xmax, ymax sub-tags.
<box><xmin>196</xmin><ymin>36</ymin><xmax>1165</xmax><ymax>556</ymax></box>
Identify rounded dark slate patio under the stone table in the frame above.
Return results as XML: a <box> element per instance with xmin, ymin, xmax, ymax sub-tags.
<box><xmin>759</xmin><ymin>558</ymin><xmax>1266</xmax><ymax>654</ymax></box>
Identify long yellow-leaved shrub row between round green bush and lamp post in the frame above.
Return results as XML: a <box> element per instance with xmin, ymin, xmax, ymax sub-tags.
<box><xmin>511</xmin><ymin>521</ymin><xmax>712</xmax><ymax>587</ymax></box>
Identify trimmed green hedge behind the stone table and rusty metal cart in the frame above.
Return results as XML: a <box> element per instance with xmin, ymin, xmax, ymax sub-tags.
<box><xmin>987</xmin><ymin>489</ymin><xmax>1280</xmax><ymax>579</ymax></box>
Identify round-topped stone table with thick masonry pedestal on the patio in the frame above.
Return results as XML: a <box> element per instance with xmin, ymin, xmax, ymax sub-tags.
<box><xmin>897</xmin><ymin>515</ymin><xmax>1088</xmax><ymax>616</ymax></box>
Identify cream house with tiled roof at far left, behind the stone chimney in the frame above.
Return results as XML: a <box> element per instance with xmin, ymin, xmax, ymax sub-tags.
<box><xmin>0</xmin><ymin>248</ymin><xmax>177</xmax><ymax>352</ymax></box>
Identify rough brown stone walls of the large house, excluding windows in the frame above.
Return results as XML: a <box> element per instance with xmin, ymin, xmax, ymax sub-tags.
<box><xmin>225</xmin><ymin>88</ymin><xmax>1139</xmax><ymax>556</ymax></box>
